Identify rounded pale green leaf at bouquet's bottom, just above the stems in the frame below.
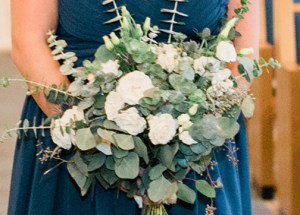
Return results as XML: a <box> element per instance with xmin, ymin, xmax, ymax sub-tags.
<box><xmin>148</xmin><ymin>176</ymin><xmax>171</xmax><ymax>202</ymax></box>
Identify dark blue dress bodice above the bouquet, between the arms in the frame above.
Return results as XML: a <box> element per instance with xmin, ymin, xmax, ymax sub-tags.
<box><xmin>57</xmin><ymin>0</ymin><xmax>228</xmax><ymax>63</ymax></box>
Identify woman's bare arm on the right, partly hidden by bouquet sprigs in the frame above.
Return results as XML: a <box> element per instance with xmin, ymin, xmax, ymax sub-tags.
<box><xmin>227</xmin><ymin>0</ymin><xmax>259</xmax><ymax>87</ymax></box>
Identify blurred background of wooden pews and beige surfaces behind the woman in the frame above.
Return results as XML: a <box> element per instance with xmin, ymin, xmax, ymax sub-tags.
<box><xmin>0</xmin><ymin>0</ymin><xmax>300</xmax><ymax>215</ymax></box>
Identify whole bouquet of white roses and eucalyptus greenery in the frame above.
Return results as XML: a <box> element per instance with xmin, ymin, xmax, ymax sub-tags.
<box><xmin>1</xmin><ymin>0</ymin><xmax>280</xmax><ymax>215</ymax></box>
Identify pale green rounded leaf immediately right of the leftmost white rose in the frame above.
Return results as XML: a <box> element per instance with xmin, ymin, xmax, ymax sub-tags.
<box><xmin>75</xmin><ymin>128</ymin><xmax>97</xmax><ymax>151</ymax></box>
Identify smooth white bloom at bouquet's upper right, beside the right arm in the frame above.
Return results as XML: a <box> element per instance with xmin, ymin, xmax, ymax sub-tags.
<box><xmin>216</xmin><ymin>41</ymin><xmax>237</xmax><ymax>63</ymax></box>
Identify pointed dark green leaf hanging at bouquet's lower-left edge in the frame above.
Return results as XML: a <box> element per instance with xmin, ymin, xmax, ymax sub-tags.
<box><xmin>67</xmin><ymin>152</ymin><xmax>88</xmax><ymax>189</ymax></box>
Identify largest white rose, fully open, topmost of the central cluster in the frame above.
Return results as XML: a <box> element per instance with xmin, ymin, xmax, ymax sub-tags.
<box><xmin>116</xmin><ymin>71</ymin><xmax>154</xmax><ymax>105</ymax></box>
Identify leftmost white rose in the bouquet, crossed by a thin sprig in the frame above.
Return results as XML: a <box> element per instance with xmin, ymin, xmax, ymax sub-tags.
<box><xmin>51</xmin><ymin>119</ymin><xmax>75</xmax><ymax>150</ymax></box>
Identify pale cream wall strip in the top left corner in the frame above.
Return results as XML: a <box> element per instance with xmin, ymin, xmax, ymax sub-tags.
<box><xmin>0</xmin><ymin>0</ymin><xmax>11</xmax><ymax>51</ymax></box>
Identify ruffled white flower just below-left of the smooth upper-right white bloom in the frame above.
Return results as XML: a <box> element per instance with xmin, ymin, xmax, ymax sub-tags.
<box><xmin>194</xmin><ymin>56</ymin><xmax>220</xmax><ymax>76</ymax></box>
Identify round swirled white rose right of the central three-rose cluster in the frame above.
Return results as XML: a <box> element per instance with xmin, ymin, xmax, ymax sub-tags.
<box><xmin>148</xmin><ymin>114</ymin><xmax>178</xmax><ymax>145</ymax></box>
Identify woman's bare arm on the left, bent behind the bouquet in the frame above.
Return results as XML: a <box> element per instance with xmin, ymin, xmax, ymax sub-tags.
<box><xmin>11</xmin><ymin>0</ymin><xmax>69</xmax><ymax>116</ymax></box>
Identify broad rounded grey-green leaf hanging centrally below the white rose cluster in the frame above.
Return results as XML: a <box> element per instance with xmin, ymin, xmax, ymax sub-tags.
<box><xmin>115</xmin><ymin>152</ymin><xmax>139</xmax><ymax>179</ymax></box>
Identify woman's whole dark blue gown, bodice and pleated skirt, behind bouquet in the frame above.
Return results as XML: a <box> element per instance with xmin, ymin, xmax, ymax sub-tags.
<box><xmin>8</xmin><ymin>0</ymin><xmax>251</xmax><ymax>215</ymax></box>
